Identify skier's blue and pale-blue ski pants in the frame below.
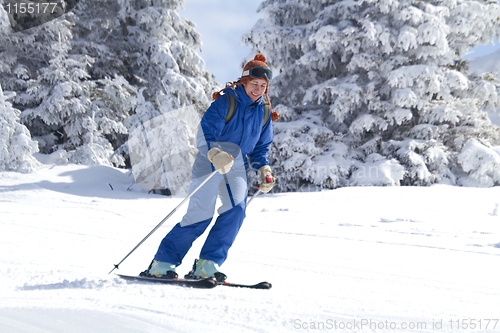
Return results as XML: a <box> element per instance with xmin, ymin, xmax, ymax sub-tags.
<box><xmin>154</xmin><ymin>154</ymin><xmax>248</xmax><ymax>266</ymax></box>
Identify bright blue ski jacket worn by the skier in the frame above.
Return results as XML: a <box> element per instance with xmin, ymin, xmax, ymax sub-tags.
<box><xmin>197</xmin><ymin>85</ymin><xmax>273</xmax><ymax>171</ymax></box>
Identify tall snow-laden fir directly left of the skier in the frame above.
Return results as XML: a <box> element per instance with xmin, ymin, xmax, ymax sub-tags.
<box><xmin>108</xmin><ymin>0</ymin><xmax>217</xmax><ymax>189</ymax></box>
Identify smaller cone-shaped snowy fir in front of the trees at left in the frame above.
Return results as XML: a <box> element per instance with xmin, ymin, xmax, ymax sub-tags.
<box><xmin>22</xmin><ymin>26</ymin><xmax>113</xmax><ymax>164</ymax></box>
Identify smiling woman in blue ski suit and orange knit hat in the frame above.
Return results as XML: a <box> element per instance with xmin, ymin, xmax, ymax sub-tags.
<box><xmin>144</xmin><ymin>54</ymin><xmax>278</xmax><ymax>282</ymax></box>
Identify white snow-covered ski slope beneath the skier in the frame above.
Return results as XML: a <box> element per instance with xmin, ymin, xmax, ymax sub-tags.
<box><xmin>0</xmin><ymin>164</ymin><xmax>500</xmax><ymax>333</ymax></box>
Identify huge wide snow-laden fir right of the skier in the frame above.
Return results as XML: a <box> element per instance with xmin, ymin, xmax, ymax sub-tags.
<box><xmin>242</xmin><ymin>0</ymin><xmax>500</xmax><ymax>190</ymax></box>
